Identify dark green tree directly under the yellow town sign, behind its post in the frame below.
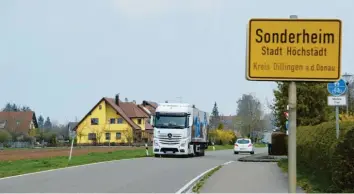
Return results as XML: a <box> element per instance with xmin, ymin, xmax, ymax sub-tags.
<box><xmin>272</xmin><ymin>82</ymin><xmax>333</xmax><ymax>131</ymax></box>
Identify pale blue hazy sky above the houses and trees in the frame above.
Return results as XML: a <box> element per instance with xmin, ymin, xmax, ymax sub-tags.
<box><xmin>0</xmin><ymin>0</ymin><xmax>354</xmax><ymax>123</ymax></box>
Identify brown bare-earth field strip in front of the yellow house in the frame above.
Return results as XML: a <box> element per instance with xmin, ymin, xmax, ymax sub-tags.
<box><xmin>0</xmin><ymin>147</ymin><xmax>143</xmax><ymax>161</ymax></box>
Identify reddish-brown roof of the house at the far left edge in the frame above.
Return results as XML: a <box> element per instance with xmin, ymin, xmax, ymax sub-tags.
<box><xmin>0</xmin><ymin>111</ymin><xmax>38</xmax><ymax>133</ymax></box>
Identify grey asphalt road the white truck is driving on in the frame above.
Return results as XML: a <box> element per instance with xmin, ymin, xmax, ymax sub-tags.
<box><xmin>0</xmin><ymin>148</ymin><xmax>266</xmax><ymax>193</ymax></box>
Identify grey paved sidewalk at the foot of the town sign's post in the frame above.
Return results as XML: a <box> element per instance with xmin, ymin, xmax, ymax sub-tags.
<box><xmin>200</xmin><ymin>162</ymin><xmax>305</xmax><ymax>193</ymax></box>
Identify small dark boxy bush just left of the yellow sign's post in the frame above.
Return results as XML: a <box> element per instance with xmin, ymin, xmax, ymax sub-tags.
<box><xmin>270</xmin><ymin>132</ymin><xmax>288</xmax><ymax>156</ymax></box>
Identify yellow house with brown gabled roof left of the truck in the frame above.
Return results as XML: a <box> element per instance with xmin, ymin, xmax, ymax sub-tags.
<box><xmin>74</xmin><ymin>95</ymin><xmax>151</xmax><ymax>144</ymax></box>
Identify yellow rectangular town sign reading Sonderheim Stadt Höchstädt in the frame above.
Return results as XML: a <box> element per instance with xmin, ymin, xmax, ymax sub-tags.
<box><xmin>247</xmin><ymin>19</ymin><xmax>341</xmax><ymax>81</ymax></box>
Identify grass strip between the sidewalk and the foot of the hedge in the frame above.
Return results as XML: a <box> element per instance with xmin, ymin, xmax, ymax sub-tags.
<box><xmin>278</xmin><ymin>159</ymin><xmax>328</xmax><ymax>193</ymax></box>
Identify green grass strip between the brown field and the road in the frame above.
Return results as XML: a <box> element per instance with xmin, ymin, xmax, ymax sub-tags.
<box><xmin>0</xmin><ymin>148</ymin><xmax>152</xmax><ymax>178</ymax></box>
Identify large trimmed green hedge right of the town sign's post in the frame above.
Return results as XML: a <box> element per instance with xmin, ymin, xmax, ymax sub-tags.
<box><xmin>297</xmin><ymin>121</ymin><xmax>354</xmax><ymax>193</ymax></box>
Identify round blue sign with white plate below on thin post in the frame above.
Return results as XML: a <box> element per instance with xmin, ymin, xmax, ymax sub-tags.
<box><xmin>327</xmin><ymin>79</ymin><xmax>348</xmax><ymax>139</ymax></box>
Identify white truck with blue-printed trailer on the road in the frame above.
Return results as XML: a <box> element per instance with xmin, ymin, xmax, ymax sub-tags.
<box><xmin>152</xmin><ymin>103</ymin><xmax>209</xmax><ymax>157</ymax></box>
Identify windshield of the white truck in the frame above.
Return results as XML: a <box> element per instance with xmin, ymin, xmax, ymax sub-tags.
<box><xmin>154</xmin><ymin>114</ymin><xmax>188</xmax><ymax>129</ymax></box>
